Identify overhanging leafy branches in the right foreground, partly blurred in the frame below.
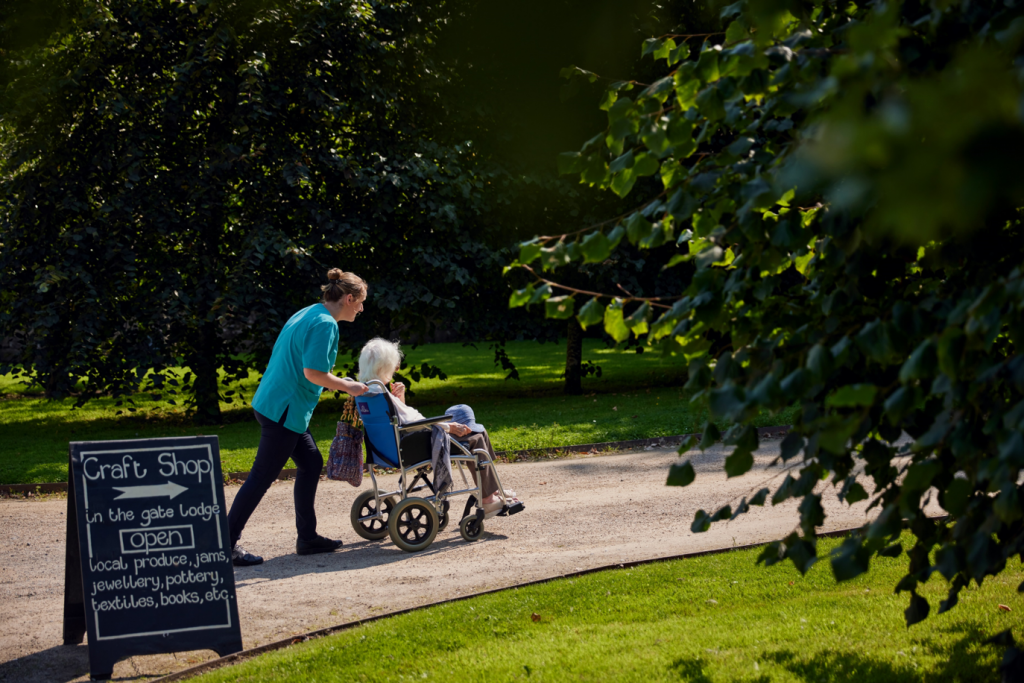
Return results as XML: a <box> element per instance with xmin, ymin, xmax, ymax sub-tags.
<box><xmin>511</xmin><ymin>0</ymin><xmax>1024</xmax><ymax>625</ymax></box>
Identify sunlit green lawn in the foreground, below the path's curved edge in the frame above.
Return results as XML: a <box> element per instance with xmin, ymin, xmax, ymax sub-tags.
<box><xmin>197</xmin><ymin>536</ymin><xmax>1024</xmax><ymax>683</ymax></box>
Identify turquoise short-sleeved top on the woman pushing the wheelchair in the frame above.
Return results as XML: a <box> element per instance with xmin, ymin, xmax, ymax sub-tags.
<box><xmin>253</xmin><ymin>303</ymin><xmax>338</xmax><ymax>434</ymax></box>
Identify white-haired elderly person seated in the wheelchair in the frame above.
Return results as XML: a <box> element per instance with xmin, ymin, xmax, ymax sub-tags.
<box><xmin>359</xmin><ymin>337</ymin><xmax>518</xmax><ymax>514</ymax></box>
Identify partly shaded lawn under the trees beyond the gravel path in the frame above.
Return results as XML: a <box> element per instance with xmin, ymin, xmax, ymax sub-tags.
<box><xmin>0</xmin><ymin>340</ymin><xmax>792</xmax><ymax>484</ymax></box>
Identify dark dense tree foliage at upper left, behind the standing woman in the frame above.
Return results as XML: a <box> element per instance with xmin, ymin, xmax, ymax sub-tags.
<box><xmin>0</xmin><ymin>0</ymin><xmax>548</xmax><ymax>420</ymax></box>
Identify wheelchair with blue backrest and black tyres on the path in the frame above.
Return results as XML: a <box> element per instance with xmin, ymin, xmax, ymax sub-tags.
<box><xmin>350</xmin><ymin>380</ymin><xmax>525</xmax><ymax>553</ymax></box>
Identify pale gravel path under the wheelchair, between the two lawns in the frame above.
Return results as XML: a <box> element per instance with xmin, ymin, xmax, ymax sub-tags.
<box><xmin>0</xmin><ymin>441</ymin><xmax>937</xmax><ymax>681</ymax></box>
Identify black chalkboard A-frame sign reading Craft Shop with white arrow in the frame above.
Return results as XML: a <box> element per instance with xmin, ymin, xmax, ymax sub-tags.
<box><xmin>65</xmin><ymin>436</ymin><xmax>242</xmax><ymax>679</ymax></box>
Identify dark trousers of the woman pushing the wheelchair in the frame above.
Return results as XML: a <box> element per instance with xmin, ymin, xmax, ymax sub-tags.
<box><xmin>227</xmin><ymin>410</ymin><xmax>324</xmax><ymax>548</ymax></box>
